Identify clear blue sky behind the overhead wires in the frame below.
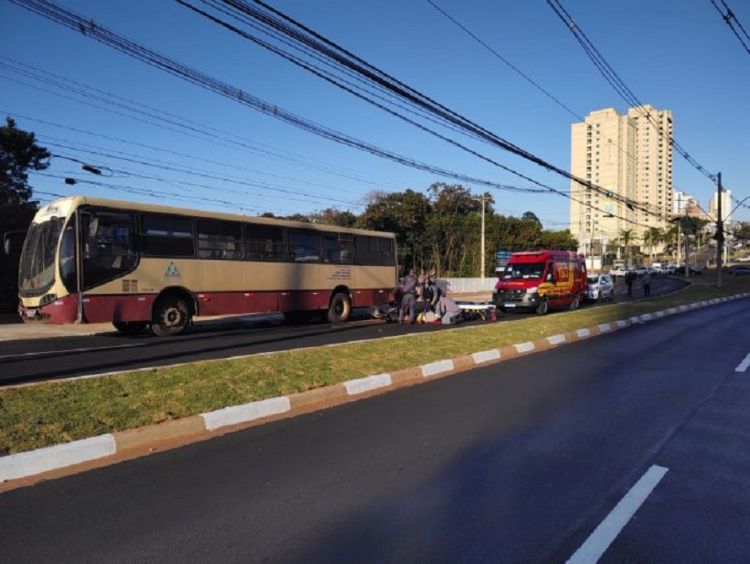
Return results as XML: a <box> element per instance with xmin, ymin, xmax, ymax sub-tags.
<box><xmin>0</xmin><ymin>0</ymin><xmax>750</xmax><ymax>228</ymax></box>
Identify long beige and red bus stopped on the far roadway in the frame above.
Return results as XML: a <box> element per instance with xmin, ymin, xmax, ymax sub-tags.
<box><xmin>19</xmin><ymin>196</ymin><xmax>397</xmax><ymax>336</ymax></box>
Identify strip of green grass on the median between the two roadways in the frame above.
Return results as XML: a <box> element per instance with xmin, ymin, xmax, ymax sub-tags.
<box><xmin>0</xmin><ymin>273</ymin><xmax>750</xmax><ymax>455</ymax></box>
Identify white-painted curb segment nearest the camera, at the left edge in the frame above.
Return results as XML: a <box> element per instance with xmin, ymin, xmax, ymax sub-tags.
<box><xmin>0</xmin><ymin>433</ymin><xmax>117</xmax><ymax>482</ymax></box>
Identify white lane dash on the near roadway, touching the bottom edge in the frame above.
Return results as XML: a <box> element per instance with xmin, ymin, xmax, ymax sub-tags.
<box><xmin>568</xmin><ymin>465</ymin><xmax>668</xmax><ymax>564</ymax></box>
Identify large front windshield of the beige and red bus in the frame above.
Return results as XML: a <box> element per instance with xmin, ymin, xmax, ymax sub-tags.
<box><xmin>18</xmin><ymin>217</ymin><xmax>65</xmax><ymax>296</ymax></box>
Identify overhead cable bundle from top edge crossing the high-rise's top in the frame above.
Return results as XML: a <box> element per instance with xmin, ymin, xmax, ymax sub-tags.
<box><xmin>546</xmin><ymin>0</ymin><xmax>717</xmax><ymax>183</ymax></box>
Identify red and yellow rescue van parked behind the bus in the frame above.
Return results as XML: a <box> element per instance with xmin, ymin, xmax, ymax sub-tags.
<box><xmin>493</xmin><ymin>251</ymin><xmax>588</xmax><ymax>315</ymax></box>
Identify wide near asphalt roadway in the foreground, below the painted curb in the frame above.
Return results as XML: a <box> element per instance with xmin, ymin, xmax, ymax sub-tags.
<box><xmin>0</xmin><ymin>294</ymin><xmax>750</xmax><ymax>563</ymax></box>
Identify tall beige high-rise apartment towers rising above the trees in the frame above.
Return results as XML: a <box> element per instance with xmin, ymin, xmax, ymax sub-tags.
<box><xmin>570</xmin><ymin>105</ymin><xmax>673</xmax><ymax>254</ymax></box>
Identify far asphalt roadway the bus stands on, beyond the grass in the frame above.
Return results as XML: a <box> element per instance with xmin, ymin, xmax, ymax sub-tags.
<box><xmin>0</xmin><ymin>278</ymin><xmax>684</xmax><ymax>385</ymax></box>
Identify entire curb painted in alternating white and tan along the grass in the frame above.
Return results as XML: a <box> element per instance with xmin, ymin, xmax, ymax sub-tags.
<box><xmin>0</xmin><ymin>293</ymin><xmax>750</xmax><ymax>487</ymax></box>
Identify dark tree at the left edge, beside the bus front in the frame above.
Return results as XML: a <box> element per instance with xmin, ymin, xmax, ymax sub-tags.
<box><xmin>0</xmin><ymin>117</ymin><xmax>50</xmax><ymax>312</ymax></box>
